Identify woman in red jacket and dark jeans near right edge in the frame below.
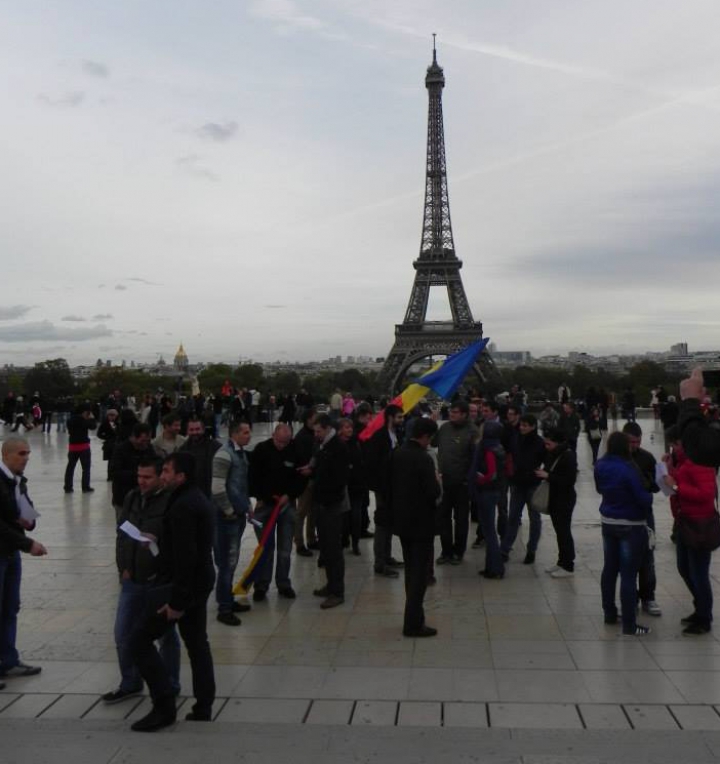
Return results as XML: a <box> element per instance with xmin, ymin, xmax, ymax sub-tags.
<box><xmin>664</xmin><ymin>450</ymin><xmax>717</xmax><ymax>634</ymax></box>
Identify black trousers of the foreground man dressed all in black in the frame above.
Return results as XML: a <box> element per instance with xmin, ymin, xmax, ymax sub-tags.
<box><xmin>130</xmin><ymin>592</ymin><xmax>215</xmax><ymax>715</ymax></box>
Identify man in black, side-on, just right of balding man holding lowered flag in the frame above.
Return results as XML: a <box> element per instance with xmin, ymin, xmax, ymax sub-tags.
<box><xmin>312</xmin><ymin>414</ymin><xmax>350</xmax><ymax>610</ymax></box>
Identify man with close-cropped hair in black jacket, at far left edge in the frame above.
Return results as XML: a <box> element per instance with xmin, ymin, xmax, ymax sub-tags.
<box><xmin>0</xmin><ymin>438</ymin><xmax>47</xmax><ymax>689</ymax></box>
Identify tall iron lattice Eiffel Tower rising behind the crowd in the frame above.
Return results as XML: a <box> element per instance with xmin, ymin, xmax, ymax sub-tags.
<box><xmin>378</xmin><ymin>40</ymin><xmax>492</xmax><ymax>393</ymax></box>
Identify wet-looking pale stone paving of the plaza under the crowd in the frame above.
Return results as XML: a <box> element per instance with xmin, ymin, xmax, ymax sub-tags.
<box><xmin>0</xmin><ymin>420</ymin><xmax>720</xmax><ymax>764</ymax></box>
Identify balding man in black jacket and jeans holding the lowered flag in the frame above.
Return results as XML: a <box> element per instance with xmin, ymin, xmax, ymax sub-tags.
<box><xmin>248</xmin><ymin>424</ymin><xmax>307</xmax><ymax>602</ymax></box>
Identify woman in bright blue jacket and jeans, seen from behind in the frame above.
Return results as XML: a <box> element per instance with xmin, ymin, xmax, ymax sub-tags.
<box><xmin>595</xmin><ymin>432</ymin><xmax>652</xmax><ymax>636</ymax></box>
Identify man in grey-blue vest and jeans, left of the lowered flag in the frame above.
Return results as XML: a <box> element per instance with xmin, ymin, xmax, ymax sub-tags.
<box><xmin>212</xmin><ymin>422</ymin><xmax>252</xmax><ymax>626</ymax></box>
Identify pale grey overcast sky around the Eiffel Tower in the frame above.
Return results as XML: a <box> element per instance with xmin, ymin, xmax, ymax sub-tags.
<box><xmin>0</xmin><ymin>0</ymin><xmax>720</xmax><ymax>364</ymax></box>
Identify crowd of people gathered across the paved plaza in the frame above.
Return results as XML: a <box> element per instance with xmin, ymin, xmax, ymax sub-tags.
<box><xmin>0</xmin><ymin>373</ymin><xmax>720</xmax><ymax>731</ymax></box>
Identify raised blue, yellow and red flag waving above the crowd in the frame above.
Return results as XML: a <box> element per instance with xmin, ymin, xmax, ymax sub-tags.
<box><xmin>358</xmin><ymin>337</ymin><xmax>490</xmax><ymax>440</ymax></box>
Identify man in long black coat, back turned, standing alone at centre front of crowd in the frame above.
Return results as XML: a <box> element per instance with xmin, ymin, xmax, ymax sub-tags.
<box><xmin>389</xmin><ymin>418</ymin><xmax>440</xmax><ymax>637</ymax></box>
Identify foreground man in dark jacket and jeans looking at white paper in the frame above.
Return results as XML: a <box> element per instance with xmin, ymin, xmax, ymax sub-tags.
<box><xmin>102</xmin><ymin>458</ymin><xmax>180</xmax><ymax>705</ymax></box>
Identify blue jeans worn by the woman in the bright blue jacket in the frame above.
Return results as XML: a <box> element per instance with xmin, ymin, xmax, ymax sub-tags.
<box><xmin>600</xmin><ymin>523</ymin><xmax>648</xmax><ymax>633</ymax></box>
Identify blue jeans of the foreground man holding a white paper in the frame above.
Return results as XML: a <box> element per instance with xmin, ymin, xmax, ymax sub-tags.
<box><xmin>115</xmin><ymin>580</ymin><xmax>180</xmax><ymax>695</ymax></box>
